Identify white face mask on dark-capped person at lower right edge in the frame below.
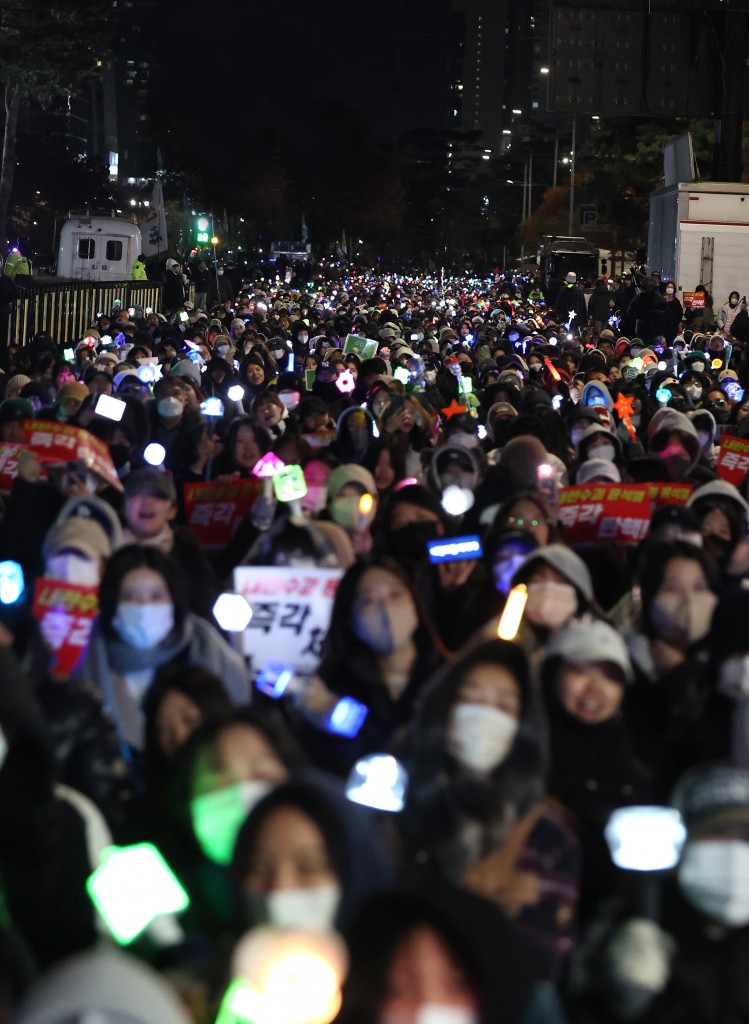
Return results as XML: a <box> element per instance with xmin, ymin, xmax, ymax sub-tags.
<box><xmin>678</xmin><ymin>840</ymin><xmax>749</xmax><ymax>928</ymax></box>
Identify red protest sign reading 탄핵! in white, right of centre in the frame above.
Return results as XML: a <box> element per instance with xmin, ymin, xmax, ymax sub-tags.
<box><xmin>559</xmin><ymin>483</ymin><xmax>651</xmax><ymax>547</ymax></box>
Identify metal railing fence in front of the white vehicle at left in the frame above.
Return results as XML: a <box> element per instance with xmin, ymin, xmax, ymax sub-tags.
<box><xmin>8</xmin><ymin>279</ymin><xmax>194</xmax><ymax>345</ymax></box>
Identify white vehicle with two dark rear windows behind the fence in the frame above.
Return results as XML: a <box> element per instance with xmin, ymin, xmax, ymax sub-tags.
<box><xmin>57</xmin><ymin>214</ymin><xmax>141</xmax><ymax>281</ymax></box>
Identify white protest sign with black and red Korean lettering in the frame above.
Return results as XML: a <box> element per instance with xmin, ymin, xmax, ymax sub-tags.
<box><xmin>234</xmin><ymin>565</ymin><xmax>343</xmax><ymax>674</ymax></box>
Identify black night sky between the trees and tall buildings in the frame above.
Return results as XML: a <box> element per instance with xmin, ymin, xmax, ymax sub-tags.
<box><xmin>159</xmin><ymin>0</ymin><xmax>449</xmax><ymax>145</ymax></box>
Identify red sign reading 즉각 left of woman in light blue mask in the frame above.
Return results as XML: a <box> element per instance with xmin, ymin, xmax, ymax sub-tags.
<box><xmin>32</xmin><ymin>579</ymin><xmax>98</xmax><ymax>676</ymax></box>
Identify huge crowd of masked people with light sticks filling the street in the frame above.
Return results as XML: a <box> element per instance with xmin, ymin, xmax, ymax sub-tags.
<box><xmin>0</xmin><ymin>262</ymin><xmax>749</xmax><ymax>1024</ymax></box>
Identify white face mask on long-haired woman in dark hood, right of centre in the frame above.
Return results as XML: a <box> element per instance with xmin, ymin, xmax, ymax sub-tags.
<box><xmin>447</xmin><ymin>703</ymin><xmax>517</xmax><ymax>775</ymax></box>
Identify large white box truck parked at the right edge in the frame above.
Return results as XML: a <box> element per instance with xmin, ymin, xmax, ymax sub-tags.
<box><xmin>648</xmin><ymin>181</ymin><xmax>749</xmax><ymax>310</ymax></box>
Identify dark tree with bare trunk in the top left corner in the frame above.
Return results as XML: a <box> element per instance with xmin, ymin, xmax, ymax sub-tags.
<box><xmin>0</xmin><ymin>0</ymin><xmax>111</xmax><ymax>249</ymax></box>
